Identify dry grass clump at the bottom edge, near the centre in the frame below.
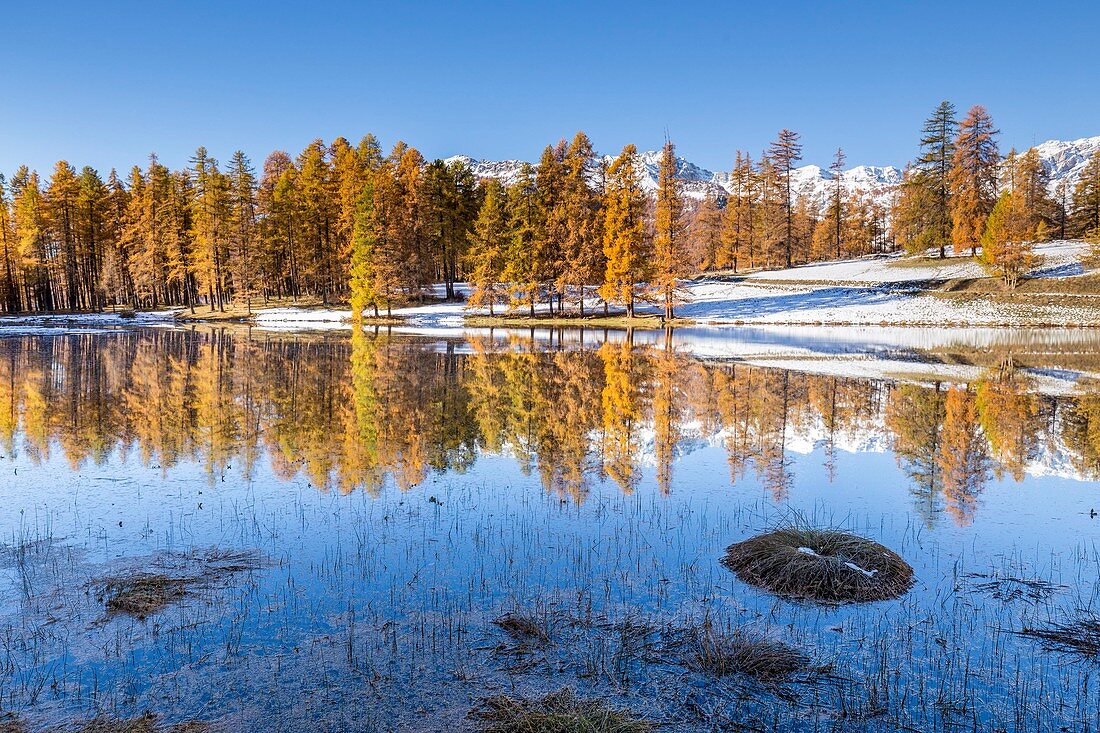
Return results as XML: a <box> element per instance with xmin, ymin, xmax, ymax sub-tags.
<box><xmin>470</xmin><ymin>688</ymin><xmax>655</xmax><ymax>733</ymax></box>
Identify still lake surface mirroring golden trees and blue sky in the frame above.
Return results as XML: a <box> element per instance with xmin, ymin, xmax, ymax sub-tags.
<box><xmin>0</xmin><ymin>328</ymin><xmax>1100</xmax><ymax>732</ymax></box>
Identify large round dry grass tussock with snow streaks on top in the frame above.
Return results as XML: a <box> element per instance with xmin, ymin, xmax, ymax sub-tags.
<box><xmin>722</xmin><ymin>527</ymin><xmax>913</xmax><ymax>603</ymax></box>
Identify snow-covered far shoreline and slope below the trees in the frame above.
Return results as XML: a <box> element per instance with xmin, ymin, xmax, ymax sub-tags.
<box><xmin>0</xmin><ymin>241</ymin><xmax>1100</xmax><ymax>332</ymax></box>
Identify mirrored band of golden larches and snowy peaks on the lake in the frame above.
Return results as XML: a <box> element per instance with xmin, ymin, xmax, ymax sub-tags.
<box><xmin>0</xmin><ymin>330</ymin><xmax>1100</xmax><ymax>524</ymax></box>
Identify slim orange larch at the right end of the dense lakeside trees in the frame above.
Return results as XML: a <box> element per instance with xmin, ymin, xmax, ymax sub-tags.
<box><xmin>652</xmin><ymin>141</ymin><xmax>686</xmax><ymax>320</ymax></box>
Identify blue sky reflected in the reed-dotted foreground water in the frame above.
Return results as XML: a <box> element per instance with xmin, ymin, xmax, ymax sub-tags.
<box><xmin>0</xmin><ymin>327</ymin><xmax>1100</xmax><ymax>730</ymax></box>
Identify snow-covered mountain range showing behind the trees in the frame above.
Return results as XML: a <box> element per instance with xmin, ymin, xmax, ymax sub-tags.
<box><xmin>447</xmin><ymin>135</ymin><xmax>1100</xmax><ymax>214</ymax></box>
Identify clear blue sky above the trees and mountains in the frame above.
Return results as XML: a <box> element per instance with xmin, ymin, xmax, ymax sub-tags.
<box><xmin>0</xmin><ymin>0</ymin><xmax>1100</xmax><ymax>173</ymax></box>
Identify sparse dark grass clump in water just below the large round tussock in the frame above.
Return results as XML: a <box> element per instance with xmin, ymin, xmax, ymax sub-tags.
<box><xmin>688</xmin><ymin>624</ymin><xmax>820</xmax><ymax>682</ymax></box>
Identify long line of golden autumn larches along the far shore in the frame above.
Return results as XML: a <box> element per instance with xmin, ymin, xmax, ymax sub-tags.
<box><xmin>0</xmin><ymin>102</ymin><xmax>1100</xmax><ymax>316</ymax></box>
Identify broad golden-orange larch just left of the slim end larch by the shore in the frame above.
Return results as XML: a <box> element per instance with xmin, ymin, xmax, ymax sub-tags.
<box><xmin>600</xmin><ymin>145</ymin><xmax>651</xmax><ymax>318</ymax></box>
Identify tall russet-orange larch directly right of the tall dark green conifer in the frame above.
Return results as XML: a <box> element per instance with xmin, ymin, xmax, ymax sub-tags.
<box><xmin>948</xmin><ymin>105</ymin><xmax>1001</xmax><ymax>254</ymax></box>
